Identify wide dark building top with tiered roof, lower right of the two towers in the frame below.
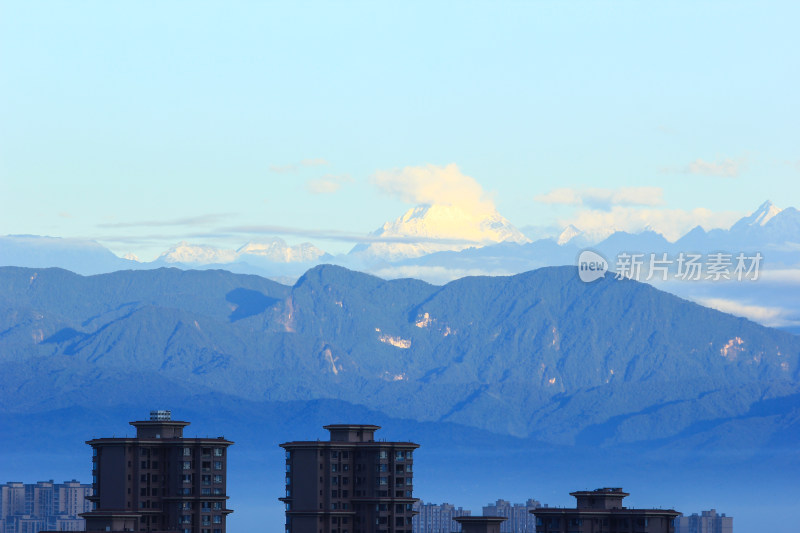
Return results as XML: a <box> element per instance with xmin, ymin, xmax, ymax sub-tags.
<box><xmin>531</xmin><ymin>488</ymin><xmax>680</xmax><ymax>533</ymax></box>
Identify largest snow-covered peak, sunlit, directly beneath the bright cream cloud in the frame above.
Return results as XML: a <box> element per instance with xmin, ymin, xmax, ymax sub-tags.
<box><xmin>351</xmin><ymin>204</ymin><xmax>530</xmax><ymax>261</ymax></box>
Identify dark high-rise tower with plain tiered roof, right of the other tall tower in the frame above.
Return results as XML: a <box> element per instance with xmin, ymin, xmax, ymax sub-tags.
<box><xmin>280</xmin><ymin>424</ymin><xmax>419</xmax><ymax>533</ymax></box>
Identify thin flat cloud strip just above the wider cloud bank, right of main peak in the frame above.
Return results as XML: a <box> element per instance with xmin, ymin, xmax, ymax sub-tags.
<box><xmin>534</xmin><ymin>187</ymin><xmax>664</xmax><ymax>210</ymax></box>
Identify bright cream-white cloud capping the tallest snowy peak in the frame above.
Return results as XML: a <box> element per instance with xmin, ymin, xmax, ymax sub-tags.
<box><xmin>372</xmin><ymin>163</ymin><xmax>495</xmax><ymax>213</ymax></box>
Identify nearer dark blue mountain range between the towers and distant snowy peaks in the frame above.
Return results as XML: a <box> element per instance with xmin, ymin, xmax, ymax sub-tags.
<box><xmin>0</xmin><ymin>264</ymin><xmax>800</xmax><ymax>532</ymax></box>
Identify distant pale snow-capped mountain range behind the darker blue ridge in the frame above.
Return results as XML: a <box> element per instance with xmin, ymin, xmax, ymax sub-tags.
<box><xmin>0</xmin><ymin>202</ymin><xmax>800</xmax><ymax>332</ymax></box>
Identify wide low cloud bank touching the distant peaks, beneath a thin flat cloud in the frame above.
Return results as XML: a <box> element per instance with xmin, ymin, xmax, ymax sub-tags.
<box><xmin>561</xmin><ymin>206</ymin><xmax>742</xmax><ymax>241</ymax></box>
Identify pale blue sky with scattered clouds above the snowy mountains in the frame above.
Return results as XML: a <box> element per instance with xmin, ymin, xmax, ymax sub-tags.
<box><xmin>0</xmin><ymin>0</ymin><xmax>800</xmax><ymax>259</ymax></box>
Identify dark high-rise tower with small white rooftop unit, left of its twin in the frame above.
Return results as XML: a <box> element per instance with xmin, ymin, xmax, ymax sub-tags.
<box><xmin>83</xmin><ymin>411</ymin><xmax>233</xmax><ymax>533</ymax></box>
